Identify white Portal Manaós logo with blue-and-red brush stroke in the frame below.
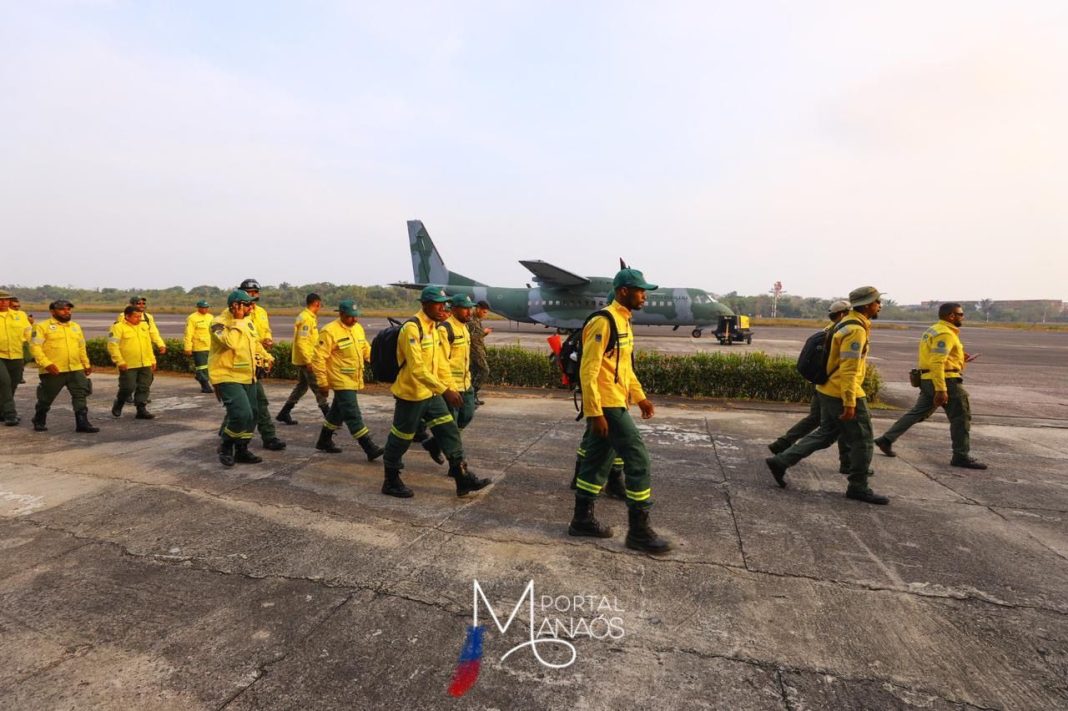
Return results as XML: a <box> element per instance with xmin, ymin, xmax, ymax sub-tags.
<box><xmin>449</xmin><ymin>580</ymin><xmax>625</xmax><ymax>696</ymax></box>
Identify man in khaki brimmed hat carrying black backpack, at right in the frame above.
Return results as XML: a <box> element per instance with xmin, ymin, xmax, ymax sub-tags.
<box><xmin>764</xmin><ymin>286</ymin><xmax>890</xmax><ymax>504</ymax></box>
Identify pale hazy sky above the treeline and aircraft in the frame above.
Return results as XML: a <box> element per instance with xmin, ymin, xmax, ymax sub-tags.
<box><xmin>0</xmin><ymin>0</ymin><xmax>1068</xmax><ymax>303</ymax></box>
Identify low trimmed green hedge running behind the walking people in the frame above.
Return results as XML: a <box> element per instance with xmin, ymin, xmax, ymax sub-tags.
<box><xmin>88</xmin><ymin>338</ymin><xmax>882</xmax><ymax>402</ymax></box>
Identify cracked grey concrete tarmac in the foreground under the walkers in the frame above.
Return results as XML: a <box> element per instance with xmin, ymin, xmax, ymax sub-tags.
<box><xmin>0</xmin><ymin>367</ymin><xmax>1068</xmax><ymax>711</ymax></box>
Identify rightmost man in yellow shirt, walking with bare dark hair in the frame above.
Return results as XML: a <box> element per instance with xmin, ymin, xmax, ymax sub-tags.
<box><xmin>875</xmin><ymin>302</ymin><xmax>987</xmax><ymax>469</ymax></box>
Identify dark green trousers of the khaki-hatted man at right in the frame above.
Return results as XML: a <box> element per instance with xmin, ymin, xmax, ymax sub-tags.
<box><xmin>773</xmin><ymin>393</ymin><xmax>874</xmax><ymax>493</ymax></box>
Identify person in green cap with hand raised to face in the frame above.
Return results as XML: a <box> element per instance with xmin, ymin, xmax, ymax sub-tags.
<box><xmin>207</xmin><ymin>289</ymin><xmax>263</xmax><ymax>467</ymax></box>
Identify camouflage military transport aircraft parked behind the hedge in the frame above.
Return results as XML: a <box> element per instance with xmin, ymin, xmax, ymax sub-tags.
<box><xmin>395</xmin><ymin>220</ymin><xmax>733</xmax><ymax>338</ymax></box>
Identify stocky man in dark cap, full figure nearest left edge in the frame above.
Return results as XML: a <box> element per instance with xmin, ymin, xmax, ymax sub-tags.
<box><xmin>30</xmin><ymin>299</ymin><xmax>100</xmax><ymax>432</ymax></box>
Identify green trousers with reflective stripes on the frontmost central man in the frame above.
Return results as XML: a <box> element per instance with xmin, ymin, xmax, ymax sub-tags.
<box><xmin>576</xmin><ymin>408</ymin><xmax>653</xmax><ymax>508</ymax></box>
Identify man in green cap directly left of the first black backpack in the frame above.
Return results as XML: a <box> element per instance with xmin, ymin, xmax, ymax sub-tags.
<box><xmin>310</xmin><ymin>299</ymin><xmax>384</xmax><ymax>461</ymax></box>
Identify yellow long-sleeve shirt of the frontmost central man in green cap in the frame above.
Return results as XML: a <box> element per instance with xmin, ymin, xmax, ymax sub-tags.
<box><xmin>579</xmin><ymin>302</ymin><xmax>645</xmax><ymax>417</ymax></box>
